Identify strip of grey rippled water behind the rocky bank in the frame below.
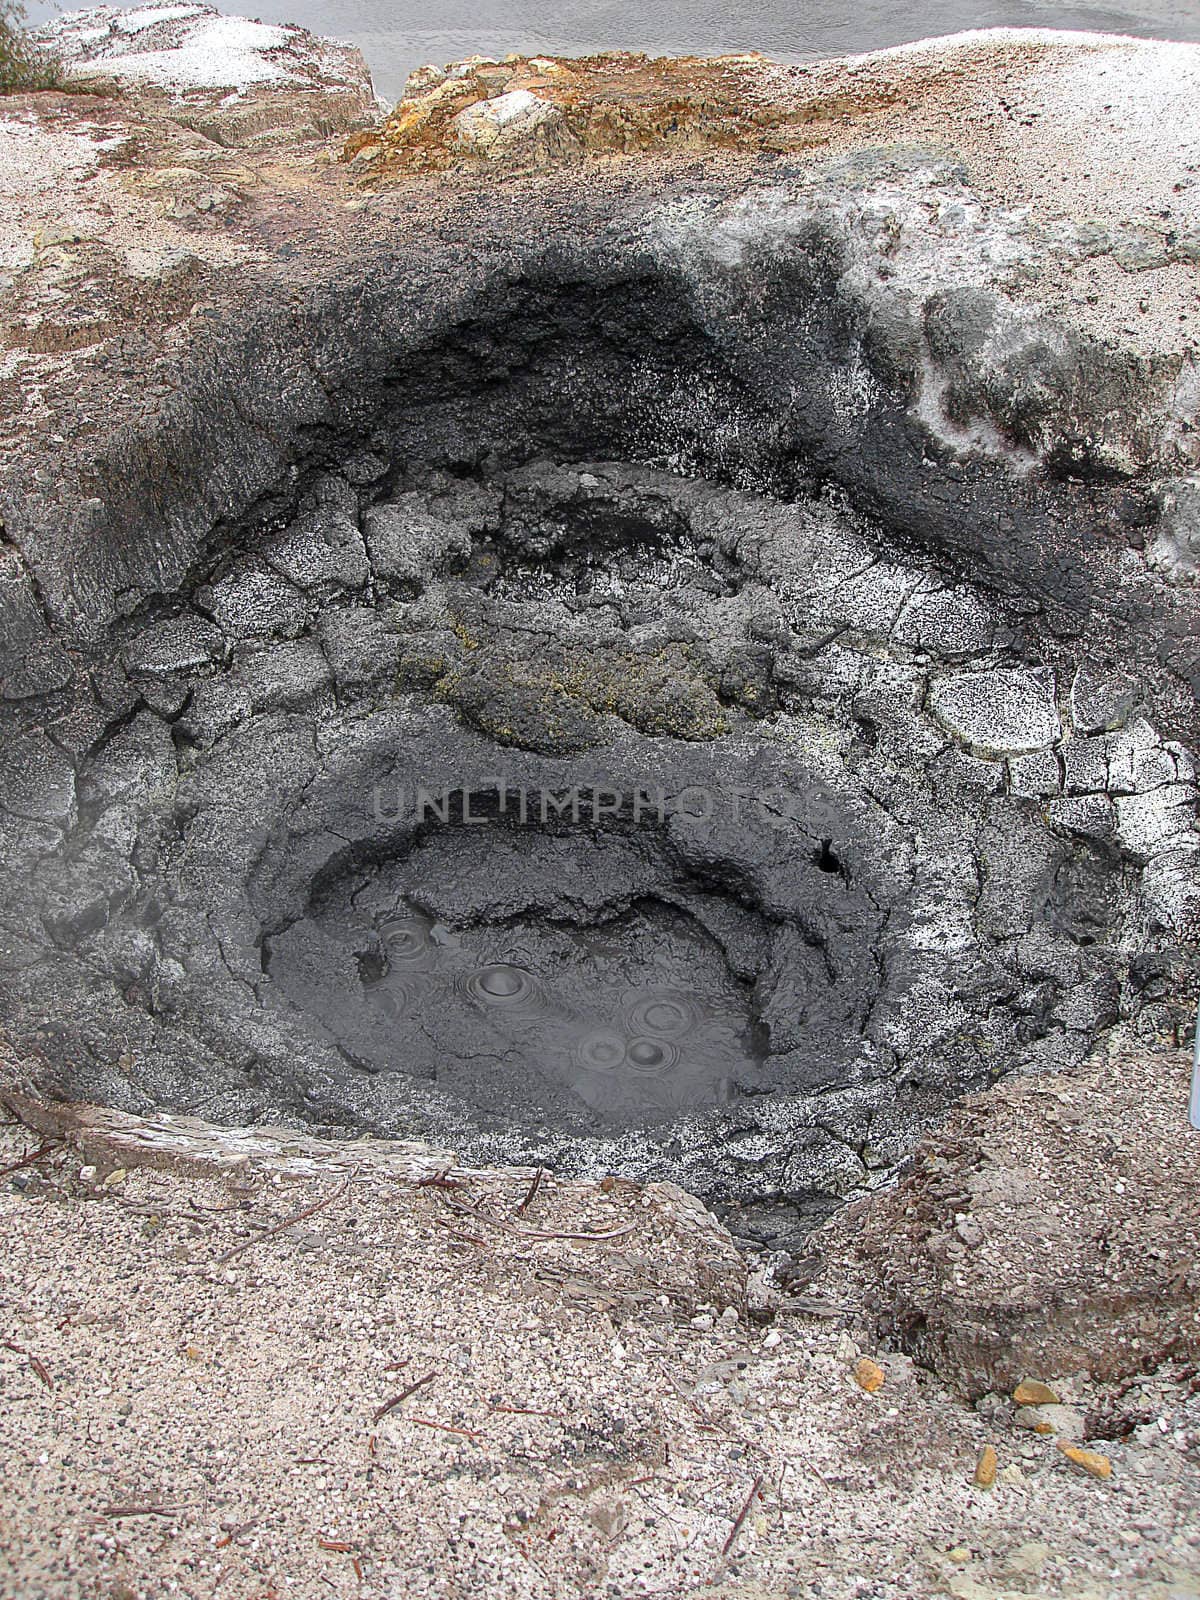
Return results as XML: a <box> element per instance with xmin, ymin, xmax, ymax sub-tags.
<box><xmin>27</xmin><ymin>0</ymin><xmax>1200</xmax><ymax>99</ymax></box>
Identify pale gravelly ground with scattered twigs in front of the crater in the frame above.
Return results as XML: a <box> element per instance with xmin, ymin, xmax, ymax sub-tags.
<box><xmin>0</xmin><ymin>1126</ymin><xmax>1200</xmax><ymax>1600</ymax></box>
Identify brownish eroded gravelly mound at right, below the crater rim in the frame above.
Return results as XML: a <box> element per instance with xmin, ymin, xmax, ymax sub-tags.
<box><xmin>830</xmin><ymin>1045</ymin><xmax>1200</xmax><ymax>1398</ymax></box>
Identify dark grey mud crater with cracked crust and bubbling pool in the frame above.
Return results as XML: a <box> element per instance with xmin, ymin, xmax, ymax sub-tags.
<box><xmin>3</xmin><ymin>252</ymin><xmax>1195</xmax><ymax>1245</ymax></box>
